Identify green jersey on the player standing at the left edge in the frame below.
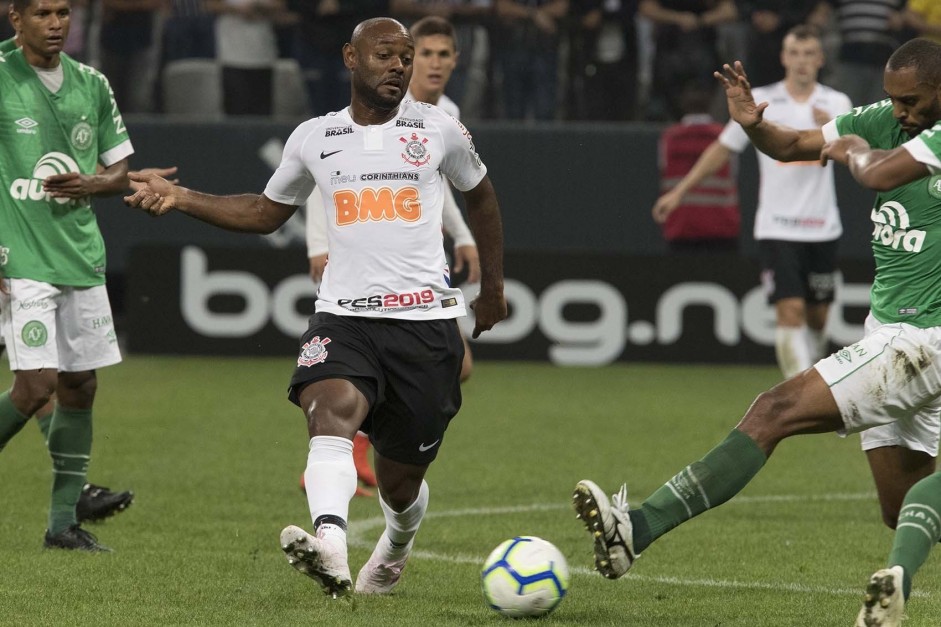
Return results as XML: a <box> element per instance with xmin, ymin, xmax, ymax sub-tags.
<box><xmin>0</xmin><ymin>50</ymin><xmax>134</xmax><ymax>287</ymax></box>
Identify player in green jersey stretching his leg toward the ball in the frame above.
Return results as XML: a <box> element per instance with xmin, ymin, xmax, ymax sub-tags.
<box><xmin>573</xmin><ymin>39</ymin><xmax>941</xmax><ymax>627</ymax></box>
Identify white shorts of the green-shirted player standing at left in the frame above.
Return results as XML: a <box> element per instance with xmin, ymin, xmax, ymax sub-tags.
<box><xmin>0</xmin><ymin>279</ymin><xmax>121</xmax><ymax>372</ymax></box>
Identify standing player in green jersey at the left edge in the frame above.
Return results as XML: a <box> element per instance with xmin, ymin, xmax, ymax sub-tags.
<box><xmin>0</xmin><ymin>0</ymin><xmax>133</xmax><ymax>551</ymax></box>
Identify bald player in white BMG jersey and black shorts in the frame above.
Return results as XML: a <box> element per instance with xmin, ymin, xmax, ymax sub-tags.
<box><xmin>125</xmin><ymin>18</ymin><xmax>507</xmax><ymax>597</ymax></box>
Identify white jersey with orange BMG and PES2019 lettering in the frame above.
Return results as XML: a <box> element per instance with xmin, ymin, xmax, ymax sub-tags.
<box><xmin>265</xmin><ymin>101</ymin><xmax>487</xmax><ymax>320</ymax></box>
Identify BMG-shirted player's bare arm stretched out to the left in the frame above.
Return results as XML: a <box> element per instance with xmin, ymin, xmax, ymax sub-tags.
<box><xmin>124</xmin><ymin>174</ymin><xmax>297</xmax><ymax>233</ymax></box>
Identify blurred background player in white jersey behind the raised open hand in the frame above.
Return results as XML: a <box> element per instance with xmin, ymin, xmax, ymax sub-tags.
<box><xmin>653</xmin><ymin>26</ymin><xmax>852</xmax><ymax>378</ymax></box>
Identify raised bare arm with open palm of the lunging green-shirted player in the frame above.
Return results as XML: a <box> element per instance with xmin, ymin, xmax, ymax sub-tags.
<box><xmin>713</xmin><ymin>61</ymin><xmax>824</xmax><ymax>161</ymax></box>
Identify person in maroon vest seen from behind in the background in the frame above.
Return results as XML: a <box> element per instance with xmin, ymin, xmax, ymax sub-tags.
<box><xmin>654</xmin><ymin>80</ymin><xmax>741</xmax><ymax>252</ymax></box>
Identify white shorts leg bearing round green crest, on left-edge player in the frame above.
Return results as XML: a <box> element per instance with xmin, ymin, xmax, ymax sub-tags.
<box><xmin>0</xmin><ymin>279</ymin><xmax>61</xmax><ymax>371</ymax></box>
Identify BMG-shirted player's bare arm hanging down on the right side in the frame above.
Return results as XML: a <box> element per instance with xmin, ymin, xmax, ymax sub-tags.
<box><xmin>464</xmin><ymin>176</ymin><xmax>507</xmax><ymax>338</ymax></box>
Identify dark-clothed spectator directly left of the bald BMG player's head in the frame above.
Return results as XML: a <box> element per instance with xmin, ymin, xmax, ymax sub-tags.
<box><xmin>288</xmin><ymin>0</ymin><xmax>389</xmax><ymax>116</ymax></box>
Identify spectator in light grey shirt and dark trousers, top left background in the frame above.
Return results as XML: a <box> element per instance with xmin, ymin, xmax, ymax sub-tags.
<box><xmin>206</xmin><ymin>0</ymin><xmax>288</xmax><ymax>115</ymax></box>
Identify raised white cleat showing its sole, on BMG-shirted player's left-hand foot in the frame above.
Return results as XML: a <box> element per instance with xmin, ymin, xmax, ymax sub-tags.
<box><xmin>281</xmin><ymin>525</ymin><xmax>352</xmax><ymax>599</ymax></box>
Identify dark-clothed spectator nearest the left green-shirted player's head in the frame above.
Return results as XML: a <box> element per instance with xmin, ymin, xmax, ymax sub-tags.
<box><xmin>98</xmin><ymin>0</ymin><xmax>162</xmax><ymax>113</ymax></box>
